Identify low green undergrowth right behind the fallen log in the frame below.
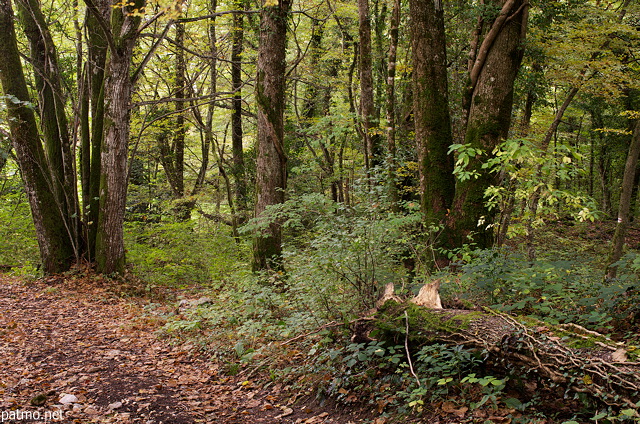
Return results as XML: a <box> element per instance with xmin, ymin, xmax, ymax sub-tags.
<box><xmin>450</xmin><ymin>249</ymin><xmax>640</xmax><ymax>329</ymax></box>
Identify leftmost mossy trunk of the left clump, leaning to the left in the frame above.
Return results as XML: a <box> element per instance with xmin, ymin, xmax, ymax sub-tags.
<box><xmin>0</xmin><ymin>0</ymin><xmax>76</xmax><ymax>274</ymax></box>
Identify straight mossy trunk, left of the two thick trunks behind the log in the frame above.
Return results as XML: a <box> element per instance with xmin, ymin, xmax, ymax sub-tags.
<box><xmin>410</xmin><ymin>0</ymin><xmax>455</xmax><ymax>262</ymax></box>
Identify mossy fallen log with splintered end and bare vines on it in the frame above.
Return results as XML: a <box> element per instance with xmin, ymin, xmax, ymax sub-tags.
<box><xmin>352</xmin><ymin>284</ymin><xmax>640</xmax><ymax>409</ymax></box>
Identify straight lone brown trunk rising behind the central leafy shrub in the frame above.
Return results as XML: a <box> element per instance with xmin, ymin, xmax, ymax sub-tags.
<box><xmin>253</xmin><ymin>0</ymin><xmax>291</xmax><ymax>271</ymax></box>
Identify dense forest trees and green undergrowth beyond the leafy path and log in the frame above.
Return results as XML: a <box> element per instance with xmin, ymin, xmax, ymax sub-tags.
<box><xmin>0</xmin><ymin>0</ymin><xmax>640</xmax><ymax>420</ymax></box>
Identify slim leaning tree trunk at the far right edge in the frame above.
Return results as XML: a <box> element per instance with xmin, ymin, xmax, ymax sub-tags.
<box><xmin>607</xmin><ymin>119</ymin><xmax>640</xmax><ymax>278</ymax></box>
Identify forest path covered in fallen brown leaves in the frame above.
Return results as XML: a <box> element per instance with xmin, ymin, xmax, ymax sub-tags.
<box><xmin>0</xmin><ymin>274</ymin><xmax>375</xmax><ymax>424</ymax></box>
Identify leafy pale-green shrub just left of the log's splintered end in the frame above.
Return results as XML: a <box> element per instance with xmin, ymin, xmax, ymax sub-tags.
<box><xmin>243</xmin><ymin>187</ymin><xmax>421</xmax><ymax>318</ymax></box>
